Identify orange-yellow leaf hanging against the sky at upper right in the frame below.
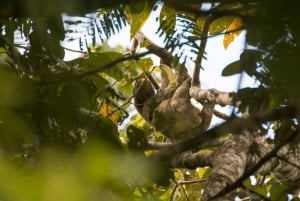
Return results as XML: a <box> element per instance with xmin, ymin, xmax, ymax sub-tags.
<box><xmin>223</xmin><ymin>17</ymin><xmax>243</xmax><ymax>49</ymax></box>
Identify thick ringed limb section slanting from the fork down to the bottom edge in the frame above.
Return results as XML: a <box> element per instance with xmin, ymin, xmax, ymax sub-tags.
<box><xmin>201</xmin><ymin>132</ymin><xmax>253</xmax><ymax>201</ymax></box>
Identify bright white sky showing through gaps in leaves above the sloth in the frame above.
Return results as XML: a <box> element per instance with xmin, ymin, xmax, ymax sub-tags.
<box><xmin>104</xmin><ymin>9</ymin><xmax>255</xmax><ymax>91</ymax></box>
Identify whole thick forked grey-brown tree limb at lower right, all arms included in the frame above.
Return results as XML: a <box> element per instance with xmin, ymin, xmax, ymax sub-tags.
<box><xmin>170</xmin><ymin>131</ymin><xmax>300</xmax><ymax>201</ymax></box>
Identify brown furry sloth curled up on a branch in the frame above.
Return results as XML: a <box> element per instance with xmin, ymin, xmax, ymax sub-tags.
<box><xmin>133</xmin><ymin>65</ymin><xmax>215</xmax><ymax>142</ymax></box>
